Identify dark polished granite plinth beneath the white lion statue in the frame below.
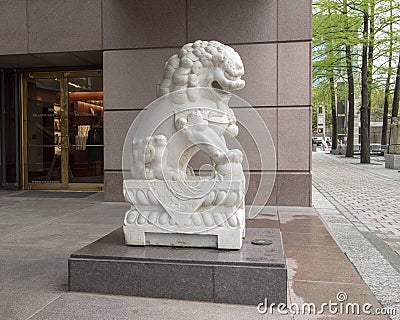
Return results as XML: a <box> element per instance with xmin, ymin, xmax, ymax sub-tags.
<box><xmin>68</xmin><ymin>228</ymin><xmax>287</xmax><ymax>305</ymax></box>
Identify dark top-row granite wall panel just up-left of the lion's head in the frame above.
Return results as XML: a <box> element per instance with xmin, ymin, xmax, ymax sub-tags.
<box><xmin>103</xmin><ymin>0</ymin><xmax>186</xmax><ymax>50</ymax></box>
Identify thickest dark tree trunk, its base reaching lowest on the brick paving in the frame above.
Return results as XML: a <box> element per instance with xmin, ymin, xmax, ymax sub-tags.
<box><xmin>361</xmin><ymin>12</ymin><xmax>371</xmax><ymax>163</ymax></box>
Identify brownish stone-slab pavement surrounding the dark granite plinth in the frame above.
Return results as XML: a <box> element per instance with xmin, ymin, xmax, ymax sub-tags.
<box><xmin>0</xmin><ymin>191</ymin><xmax>387</xmax><ymax>320</ymax></box>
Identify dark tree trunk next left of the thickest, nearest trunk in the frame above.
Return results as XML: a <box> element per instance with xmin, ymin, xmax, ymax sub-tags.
<box><xmin>346</xmin><ymin>44</ymin><xmax>354</xmax><ymax>157</ymax></box>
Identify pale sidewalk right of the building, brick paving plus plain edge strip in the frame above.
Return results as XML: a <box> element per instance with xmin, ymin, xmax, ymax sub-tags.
<box><xmin>313</xmin><ymin>152</ymin><xmax>400</xmax><ymax>319</ymax></box>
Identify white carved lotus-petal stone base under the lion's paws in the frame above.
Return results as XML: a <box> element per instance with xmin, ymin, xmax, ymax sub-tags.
<box><xmin>123</xmin><ymin>180</ymin><xmax>245</xmax><ymax>249</ymax></box>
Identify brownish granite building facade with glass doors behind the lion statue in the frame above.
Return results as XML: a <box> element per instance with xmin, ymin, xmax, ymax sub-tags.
<box><xmin>0</xmin><ymin>0</ymin><xmax>311</xmax><ymax>206</ymax></box>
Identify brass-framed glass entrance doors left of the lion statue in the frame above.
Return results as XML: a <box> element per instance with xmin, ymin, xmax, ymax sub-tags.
<box><xmin>22</xmin><ymin>71</ymin><xmax>104</xmax><ymax>190</ymax></box>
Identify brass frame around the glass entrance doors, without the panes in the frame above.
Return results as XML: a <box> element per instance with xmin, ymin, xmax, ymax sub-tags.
<box><xmin>20</xmin><ymin>70</ymin><xmax>104</xmax><ymax>191</ymax></box>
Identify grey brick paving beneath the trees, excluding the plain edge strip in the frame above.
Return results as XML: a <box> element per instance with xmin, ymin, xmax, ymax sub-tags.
<box><xmin>313</xmin><ymin>152</ymin><xmax>400</xmax><ymax>255</ymax></box>
